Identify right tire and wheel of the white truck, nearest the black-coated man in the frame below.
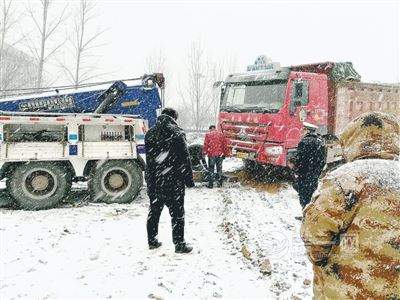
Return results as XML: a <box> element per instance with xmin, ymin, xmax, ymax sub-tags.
<box><xmin>89</xmin><ymin>160</ymin><xmax>143</xmax><ymax>203</ymax></box>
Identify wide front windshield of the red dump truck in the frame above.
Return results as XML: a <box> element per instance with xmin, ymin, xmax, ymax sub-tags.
<box><xmin>221</xmin><ymin>80</ymin><xmax>287</xmax><ymax>113</ymax></box>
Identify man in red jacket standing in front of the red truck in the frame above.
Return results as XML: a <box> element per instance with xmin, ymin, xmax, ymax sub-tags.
<box><xmin>203</xmin><ymin>125</ymin><xmax>227</xmax><ymax>188</ymax></box>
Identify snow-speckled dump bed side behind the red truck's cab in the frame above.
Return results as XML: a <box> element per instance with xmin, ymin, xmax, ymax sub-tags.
<box><xmin>328</xmin><ymin>81</ymin><xmax>400</xmax><ymax>136</ymax></box>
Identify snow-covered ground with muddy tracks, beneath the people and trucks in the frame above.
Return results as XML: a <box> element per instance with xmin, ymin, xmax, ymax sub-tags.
<box><xmin>0</xmin><ymin>159</ymin><xmax>312</xmax><ymax>299</ymax></box>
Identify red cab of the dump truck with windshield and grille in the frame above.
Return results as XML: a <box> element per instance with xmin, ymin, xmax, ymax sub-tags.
<box><xmin>219</xmin><ymin>63</ymin><xmax>358</xmax><ymax>166</ymax></box>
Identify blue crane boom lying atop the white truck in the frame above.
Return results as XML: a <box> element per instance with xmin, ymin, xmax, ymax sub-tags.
<box><xmin>0</xmin><ymin>73</ymin><xmax>164</xmax><ymax>127</ymax></box>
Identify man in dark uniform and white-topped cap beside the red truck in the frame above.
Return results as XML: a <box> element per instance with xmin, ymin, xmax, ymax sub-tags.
<box><xmin>288</xmin><ymin>122</ymin><xmax>326</xmax><ymax>208</ymax></box>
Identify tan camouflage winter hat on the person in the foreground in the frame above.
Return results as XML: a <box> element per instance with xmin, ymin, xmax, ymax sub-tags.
<box><xmin>340</xmin><ymin>112</ymin><xmax>400</xmax><ymax>161</ymax></box>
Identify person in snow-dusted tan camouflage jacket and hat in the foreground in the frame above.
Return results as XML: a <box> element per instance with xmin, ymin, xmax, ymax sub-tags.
<box><xmin>301</xmin><ymin>112</ymin><xmax>400</xmax><ymax>300</ymax></box>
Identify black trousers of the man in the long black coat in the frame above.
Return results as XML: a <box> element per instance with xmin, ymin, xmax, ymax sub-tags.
<box><xmin>147</xmin><ymin>187</ymin><xmax>185</xmax><ymax>245</ymax></box>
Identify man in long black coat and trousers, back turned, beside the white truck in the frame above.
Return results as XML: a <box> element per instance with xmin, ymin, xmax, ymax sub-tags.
<box><xmin>145</xmin><ymin>108</ymin><xmax>194</xmax><ymax>253</ymax></box>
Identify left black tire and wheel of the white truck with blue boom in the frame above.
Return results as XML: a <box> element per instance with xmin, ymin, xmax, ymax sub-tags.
<box><xmin>7</xmin><ymin>161</ymin><xmax>72</xmax><ymax>210</ymax></box>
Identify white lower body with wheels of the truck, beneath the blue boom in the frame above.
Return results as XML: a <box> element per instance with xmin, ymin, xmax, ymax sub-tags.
<box><xmin>0</xmin><ymin>112</ymin><xmax>148</xmax><ymax>209</ymax></box>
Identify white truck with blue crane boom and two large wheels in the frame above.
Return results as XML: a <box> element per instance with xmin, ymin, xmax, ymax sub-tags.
<box><xmin>0</xmin><ymin>74</ymin><xmax>164</xmax><ymax>209</ymax></box>
